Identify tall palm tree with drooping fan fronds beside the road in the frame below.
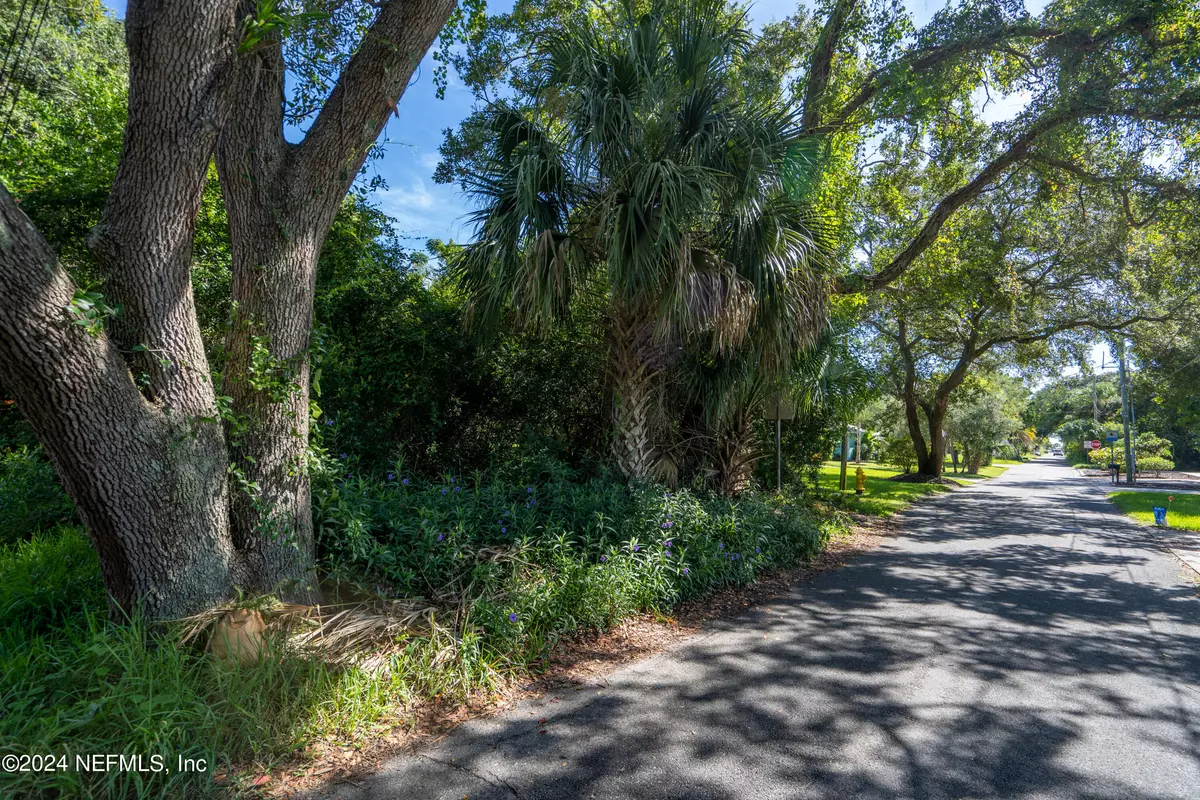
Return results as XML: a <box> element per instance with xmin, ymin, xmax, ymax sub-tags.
<box><xmin>451</xmin><ymin>0</ymin><xmax>823</xmax><ymax>479</ymax></box>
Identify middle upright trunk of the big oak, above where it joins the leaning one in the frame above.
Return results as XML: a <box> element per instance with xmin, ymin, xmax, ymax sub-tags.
<box><xmin>89</xmin><ymin>0</ymin><xmax>236</xmax><ymax>416</ymax></box>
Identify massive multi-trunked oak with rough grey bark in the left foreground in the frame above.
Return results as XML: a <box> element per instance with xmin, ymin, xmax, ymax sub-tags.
<box><xmin>0</xmin><ymin>0</ymin><xmax>454</xmax><ymax>618</ymax></box>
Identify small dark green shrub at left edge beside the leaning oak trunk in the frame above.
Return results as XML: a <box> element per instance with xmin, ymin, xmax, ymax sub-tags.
<box><xmin>0</xmin><ymin>446</ymin><xmax>74</xmax><ymax>545</ymax></box>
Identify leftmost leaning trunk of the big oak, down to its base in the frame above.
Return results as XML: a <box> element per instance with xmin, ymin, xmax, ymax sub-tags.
<box><xmin>0</xmin><ymin>187</ymin><xmax>234</xmax><ymax>618</ymax></box>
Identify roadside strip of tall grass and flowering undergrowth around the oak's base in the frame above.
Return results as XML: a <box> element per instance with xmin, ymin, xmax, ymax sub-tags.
<box><xmin>0</xmin><ymin>450</ymin><xmax>830</xmax><ymax>798</ymax></box>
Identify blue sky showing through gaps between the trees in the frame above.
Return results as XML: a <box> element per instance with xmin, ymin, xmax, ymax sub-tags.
<box><xmin>104</xmin><ymin>0</ymin><xmax>1045</xmax><ymax>247</ymax></box>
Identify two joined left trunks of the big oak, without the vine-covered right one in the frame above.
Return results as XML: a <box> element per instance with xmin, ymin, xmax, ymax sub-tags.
<box><xmin>0</xmin><ymin>0</ymin><xmax>238</xmax><ymax>618</ymax></box>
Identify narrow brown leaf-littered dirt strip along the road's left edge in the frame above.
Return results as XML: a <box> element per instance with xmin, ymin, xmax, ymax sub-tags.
<box><xmin>243</xmin><ymin>515</ymin><xmax>899</xmax><ymax>798</ymax></box>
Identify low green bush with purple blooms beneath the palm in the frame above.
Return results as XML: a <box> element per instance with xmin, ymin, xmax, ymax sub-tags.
<box><xmin>313</xmin><ymin>457</ymin><xmax>838</xmax><ymax>667</ymax></box>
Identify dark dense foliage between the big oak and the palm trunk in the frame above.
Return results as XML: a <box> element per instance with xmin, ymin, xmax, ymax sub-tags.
<box><xmin>313</xmin><ymin>198</ymin><xmax>607</xmax><ymax>475</ymax></box>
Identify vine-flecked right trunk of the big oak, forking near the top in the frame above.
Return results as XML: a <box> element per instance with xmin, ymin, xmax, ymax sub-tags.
<box><xmin>217</xmin><ymin>0</ymin><xmax>454</xmax><ymax>601</ymax></box>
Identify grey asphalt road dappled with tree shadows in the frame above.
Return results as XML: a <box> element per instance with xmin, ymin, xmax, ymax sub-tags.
<box><xmin>307</xmin><ymin>459</ymin><xmax>1200</xmax><ymax>800</ymax></box>
